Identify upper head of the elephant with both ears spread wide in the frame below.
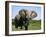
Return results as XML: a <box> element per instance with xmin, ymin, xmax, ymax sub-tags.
<box><xmin>19</xmin><ymin>9</ymin><xmax>37</xmax><ymax>19</ymax></box>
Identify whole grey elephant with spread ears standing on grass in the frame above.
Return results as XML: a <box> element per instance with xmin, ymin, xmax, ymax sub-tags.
<box><xmin>15</xmin><ymin>9</ymin><xmax>37</xmax><ymax>30</ymax></box>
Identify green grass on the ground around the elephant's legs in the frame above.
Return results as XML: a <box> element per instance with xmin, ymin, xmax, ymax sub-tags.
<box><xmin>12</xmin><ymin>20</ymin><xmax>41</xmax><ymax>31</ymax></box>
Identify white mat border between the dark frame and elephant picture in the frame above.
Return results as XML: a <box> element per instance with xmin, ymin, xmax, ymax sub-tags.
<box><xmin>9</xmin><ymin>3</ymin><xmax>44</xmax><ymax>34</ymax></box>
